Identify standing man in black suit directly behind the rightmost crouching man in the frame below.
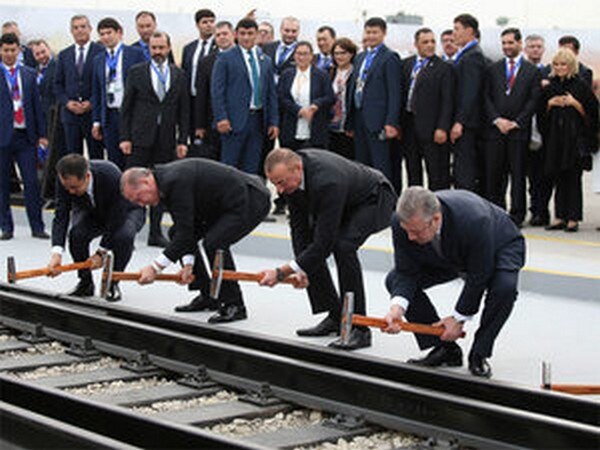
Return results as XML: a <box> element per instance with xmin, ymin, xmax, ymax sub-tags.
<box><xmin>402</xmin><ymin>28</ymin><xmax>454</xmax><ymax>191</ymax></box>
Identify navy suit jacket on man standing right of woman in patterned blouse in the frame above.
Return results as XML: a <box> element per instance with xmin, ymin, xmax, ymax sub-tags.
<box><xmin>346</xmin><ymin>45</ymin><xmax>402</xmax><ymax>133</ymax></box>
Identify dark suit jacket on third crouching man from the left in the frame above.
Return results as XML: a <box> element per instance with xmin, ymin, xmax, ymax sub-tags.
<box><xmin>284</xmin><ymin>149</ymin><xmax>393</xmax><ymax>274</ymax></box>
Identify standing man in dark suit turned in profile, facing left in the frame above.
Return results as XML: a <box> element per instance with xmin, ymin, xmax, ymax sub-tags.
<box><xmin>450</xmin><ymin>14</ymin><xmax>485</xmax><ymax>191</ymax></box>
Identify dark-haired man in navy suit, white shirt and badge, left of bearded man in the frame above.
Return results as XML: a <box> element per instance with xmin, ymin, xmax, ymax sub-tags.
<box><xmin>92</xmin><ymin>17</ymin><xmax>144</xmax><ymax>170</ymax></box>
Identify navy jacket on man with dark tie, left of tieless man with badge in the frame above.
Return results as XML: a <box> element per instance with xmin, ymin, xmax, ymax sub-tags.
<box><xmin>54</xmin><ymin>42</ymin><xmax>104</xmax><ymax>123</ymax></box>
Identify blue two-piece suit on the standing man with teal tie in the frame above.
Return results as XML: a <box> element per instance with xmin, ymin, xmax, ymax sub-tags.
<box><xmin>210</xmin><ymin>46</ymin><xmax>279</xmax><ymax>175</ymax></box>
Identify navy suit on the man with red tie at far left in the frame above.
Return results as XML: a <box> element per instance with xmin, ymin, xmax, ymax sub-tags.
<box><xmin>0</xmin><ymin>66</ymin><xmax>46</xmax><ymax>233</ymax></box>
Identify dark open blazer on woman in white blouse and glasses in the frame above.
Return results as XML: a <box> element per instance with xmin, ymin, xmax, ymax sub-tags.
<box><xmin>277</xmin><ymin>66</ymin><xmax>335</xmax><ymax>148</ymax></box>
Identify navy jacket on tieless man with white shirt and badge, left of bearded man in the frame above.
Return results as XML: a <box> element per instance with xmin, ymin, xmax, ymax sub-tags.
<box><xmin>92</xmin><ymin>44</ymin><xmax>146</xmax><ymax>127</ymax></box>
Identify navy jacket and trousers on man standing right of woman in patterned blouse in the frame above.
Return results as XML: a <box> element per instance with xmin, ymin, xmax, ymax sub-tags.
<box><xmin>346</xmin><ymin>45</ymin><xmax>402</xmax><ymax>192</ymax></box>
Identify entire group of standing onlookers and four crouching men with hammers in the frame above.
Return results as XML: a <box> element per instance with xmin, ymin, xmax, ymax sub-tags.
<box><xmin>0</xmin><ymin>9</ymin><xmax>598</xmax><ymax>376</ymax></box>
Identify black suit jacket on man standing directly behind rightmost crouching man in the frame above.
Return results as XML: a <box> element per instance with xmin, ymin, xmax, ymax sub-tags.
<box><xmin>402</xmin><ymin>55</ymin><xmax>454</xmax><ymax>142</ymax></box>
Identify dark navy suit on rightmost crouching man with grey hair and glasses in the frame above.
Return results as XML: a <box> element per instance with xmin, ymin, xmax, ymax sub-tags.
<box><xmin>386</xmin><ymin>190</ymin><xmax>525</xmax><ymax>358</ymax></box>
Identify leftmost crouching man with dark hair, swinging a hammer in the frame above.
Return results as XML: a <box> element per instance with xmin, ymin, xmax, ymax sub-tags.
<box><xmin>48</xmin><ymin>154</ymin><xmax>144</xmax><ymax>302</ymax></box>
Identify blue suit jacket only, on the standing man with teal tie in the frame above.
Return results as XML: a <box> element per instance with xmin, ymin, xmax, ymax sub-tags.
<box><xmin>210</xmin><ymin>45</ymin><xmax>279</xmax><ymax>133</ymax></box>
